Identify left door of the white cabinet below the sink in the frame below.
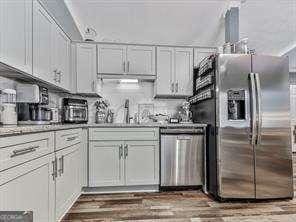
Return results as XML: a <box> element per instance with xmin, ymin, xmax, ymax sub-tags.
<box><xmin>89</xmin><ymin>141</ymin><xmax>124</xmax><ymax>187</ymax></box>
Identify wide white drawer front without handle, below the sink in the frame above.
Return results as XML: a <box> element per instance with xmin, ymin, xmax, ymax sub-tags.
<box><xmin>89</xmin><ymin>127</ymin><xmax>159</xmax><ymax>141</ymax></box>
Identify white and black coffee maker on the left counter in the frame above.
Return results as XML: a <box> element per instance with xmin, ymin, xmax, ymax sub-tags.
<box><xmin>16</xmin><ymin>84</ymin><xmax>52</xmax><ymax>125</ymax></box>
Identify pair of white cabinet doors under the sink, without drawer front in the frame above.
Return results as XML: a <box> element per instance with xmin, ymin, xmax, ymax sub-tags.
<box><xmin>89</xmin><ymin>141</ymin><xmax>159</xmax><ymax>187</ymax></box>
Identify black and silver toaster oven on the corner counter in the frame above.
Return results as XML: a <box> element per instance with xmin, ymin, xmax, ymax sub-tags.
<box><xmin>62</xmin><ymin>98</ymin><xmax>88</xmax><ymax>123</ymax></box>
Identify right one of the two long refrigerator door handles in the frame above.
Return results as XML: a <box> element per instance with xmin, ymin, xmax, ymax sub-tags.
<box><xmin>254</xmin><ymin>73</ymin><xmax>262</xmax><ymax>144</ymax></box>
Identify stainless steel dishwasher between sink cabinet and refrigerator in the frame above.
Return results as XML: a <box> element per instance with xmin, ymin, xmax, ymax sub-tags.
<box><xmin>160</xmin><ymin>127</ymin><xmax>204</xmax><ymax>187</ymax></box>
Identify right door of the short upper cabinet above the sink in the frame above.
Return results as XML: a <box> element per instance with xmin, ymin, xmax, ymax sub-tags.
<box><xmin>126</xmin><ymin>45</ymin><xmax>155</xmax><ymax>75</ymax></box>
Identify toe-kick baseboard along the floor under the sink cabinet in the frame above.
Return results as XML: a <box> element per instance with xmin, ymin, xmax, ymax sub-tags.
<box><xmin>82</xmin><ymin>185</ymin><xmax>159</xmax><ymax>194</ymax></box>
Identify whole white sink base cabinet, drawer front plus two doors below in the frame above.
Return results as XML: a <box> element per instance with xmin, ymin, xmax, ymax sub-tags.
<box><xmin>89</xmin><ymin>128</ymin><xmax>159</xmax><ymax>187</ymax></box>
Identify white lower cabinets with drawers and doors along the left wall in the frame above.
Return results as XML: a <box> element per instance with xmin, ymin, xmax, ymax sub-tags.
<box><xmin>0</xmin><ymin>129</ymin><xmax>87</xmax><ymax>222</ymax></box>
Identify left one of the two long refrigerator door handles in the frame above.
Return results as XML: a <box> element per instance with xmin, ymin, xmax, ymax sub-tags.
<box><xmin>249</xmin><ymin>73</ymin><xmax>257</xmax><ymax>146</ymax></box>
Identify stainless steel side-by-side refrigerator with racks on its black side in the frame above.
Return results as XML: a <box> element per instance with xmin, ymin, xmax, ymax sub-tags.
<box><xmin>190</xmin><ymin>54</ymin><xmax>293</xmax><ymax>199</ymax></box>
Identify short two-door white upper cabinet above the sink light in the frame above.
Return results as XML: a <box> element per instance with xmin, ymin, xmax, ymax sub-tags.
<box><xmin>98</xmin><ymin>44</ymin><xmax>155</xmax><ymax>77</ymax></box>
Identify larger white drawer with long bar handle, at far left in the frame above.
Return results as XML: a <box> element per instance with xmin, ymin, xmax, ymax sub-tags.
<box><xmin>0</xmin><ymin>132</ymin><xmax>54</xmax><ymax>171</ymax></box>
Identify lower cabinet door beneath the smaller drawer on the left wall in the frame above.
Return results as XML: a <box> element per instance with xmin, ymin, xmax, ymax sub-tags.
<box><xmin>56</xmin><ymin>143</ymin><xmax>81</xmax><ymax>221</ymax></box>
